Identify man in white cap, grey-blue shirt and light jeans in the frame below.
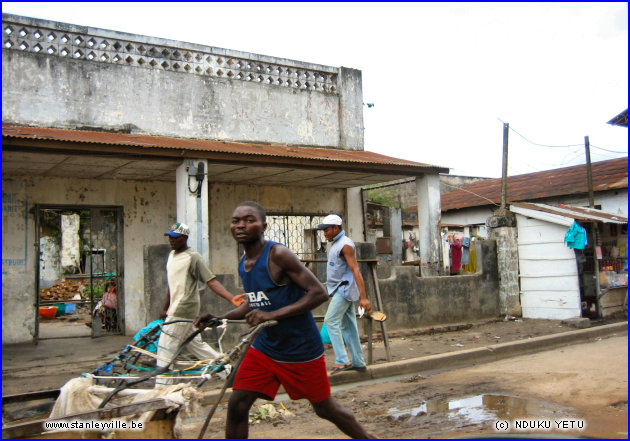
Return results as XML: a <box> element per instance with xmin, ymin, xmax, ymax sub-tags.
<box><xmin>318</xmin><ymin>214</ymin><xmax>372</xmax><ymax>375</ymax></box>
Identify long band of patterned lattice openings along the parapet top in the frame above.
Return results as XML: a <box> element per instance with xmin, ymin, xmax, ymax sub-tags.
<box><xmin>2</xmin><ymin>20</ymin><xmax>337</xmax><ymax>93</ymax></box>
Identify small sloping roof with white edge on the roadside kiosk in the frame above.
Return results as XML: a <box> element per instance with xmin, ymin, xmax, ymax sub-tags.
<box><xmin>510</xmin><ymin>202</ymin><xmax>628</xmax><ymax>226</ymax></box>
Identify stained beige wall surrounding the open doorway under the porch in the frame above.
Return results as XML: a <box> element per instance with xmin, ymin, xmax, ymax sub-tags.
<box><xmin>2</xmin><ymin>178</ymin><xmax>175</xmax><ymax>343</ymax></box>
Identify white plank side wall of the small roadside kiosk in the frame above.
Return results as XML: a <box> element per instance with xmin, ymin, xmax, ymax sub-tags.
<box><xmin>516</xmin><ymin>214</ymin><xmax>581</xmax><ymax>320</ymax></box>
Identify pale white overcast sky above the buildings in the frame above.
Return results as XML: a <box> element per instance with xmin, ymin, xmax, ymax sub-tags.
<box><xmin>2</xmin><ymin>2</ymin><xmax>628</xmax><ymax>177</ymax></box>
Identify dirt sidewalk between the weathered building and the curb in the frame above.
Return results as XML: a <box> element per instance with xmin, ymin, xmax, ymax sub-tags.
<box><xmin>2</xmin><ymin>319</ymin><xmax>607</xmax><ymax>395</ymax></box>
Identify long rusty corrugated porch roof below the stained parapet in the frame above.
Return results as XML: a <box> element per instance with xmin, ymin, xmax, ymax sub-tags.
<box><xmin>2</xmin><ymin>125</ymin><xmax>448</xmax><ymax>175</ymax></box>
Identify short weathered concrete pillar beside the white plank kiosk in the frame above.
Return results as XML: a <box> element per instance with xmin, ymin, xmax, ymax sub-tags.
<box><xmin>486</xmin><ymin>209</ymin><xmax>522</xmax><ymax>316</ymax></box>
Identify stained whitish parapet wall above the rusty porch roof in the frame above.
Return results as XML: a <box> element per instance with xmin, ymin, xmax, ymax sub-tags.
<box><xmin>2</xmin><ymin>14</ymin><xmax>363</xmax><ymax>150</ymax></box>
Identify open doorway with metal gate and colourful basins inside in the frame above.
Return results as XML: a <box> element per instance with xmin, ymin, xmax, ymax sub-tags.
<box><xmin>35</xmin><ymin>205</ymin><xmax>124</xmax><ymax>340</ymax></box>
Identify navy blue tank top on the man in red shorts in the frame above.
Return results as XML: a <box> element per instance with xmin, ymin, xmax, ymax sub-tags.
<box><xmin>238</xmin><ymin>241</ymin><xmax>324</xmax><ymax>363</ymax></box>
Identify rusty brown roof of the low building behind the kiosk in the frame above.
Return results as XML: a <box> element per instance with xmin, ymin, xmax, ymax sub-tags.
<box><xmin>441</xmin><ymin>156</ymin><xmax>628</xmax><ymax>211</ymax></box>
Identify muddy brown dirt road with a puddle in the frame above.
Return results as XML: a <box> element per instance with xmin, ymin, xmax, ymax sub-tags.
<box><xmin>184</xmin><ymin>335</ymin><xmax>628</xmax><ymax>439</ymax></box>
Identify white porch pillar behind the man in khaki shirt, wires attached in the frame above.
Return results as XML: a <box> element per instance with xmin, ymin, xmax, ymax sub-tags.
<box><xmin>175</xmin><ymin>159</ymin><xmax>210</xmax><ymax>265</ymax></box>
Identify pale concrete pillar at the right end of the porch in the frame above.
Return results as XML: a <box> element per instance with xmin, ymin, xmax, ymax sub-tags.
<box><xmin>416</xmin><ymin>174</ymin><xmax>441</xmax><ymax>277</ymax></box>
